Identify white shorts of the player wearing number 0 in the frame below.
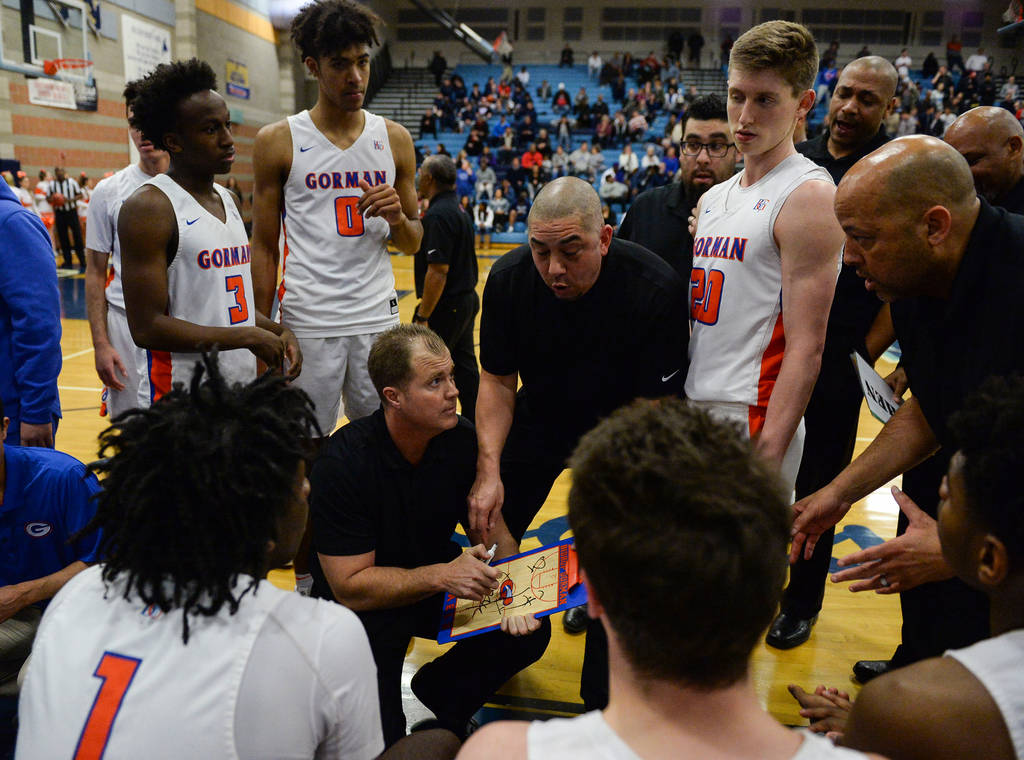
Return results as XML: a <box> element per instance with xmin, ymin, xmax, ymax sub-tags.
<box><xmin>295</xmin><ymin>331</ymin><xmax>384</xmax><ymax>436</ymax></box>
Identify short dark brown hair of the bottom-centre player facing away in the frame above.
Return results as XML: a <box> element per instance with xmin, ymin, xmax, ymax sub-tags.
<box><xmin>569</xmin><ymin>398</ymin><xmax>791</xmax><ymax>689</ymax></box>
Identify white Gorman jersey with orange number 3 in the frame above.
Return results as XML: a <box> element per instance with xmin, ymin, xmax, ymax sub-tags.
<box><xmin>146</xmin><ymin>174</ymin><xmax>256</xmax><ymax>400</ymax></box>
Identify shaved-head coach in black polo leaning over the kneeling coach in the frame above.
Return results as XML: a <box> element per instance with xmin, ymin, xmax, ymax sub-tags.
<box><xmin>470</xmin><ymin>177</ymin><xmax>689</xmax><ymax>708</ymax></box>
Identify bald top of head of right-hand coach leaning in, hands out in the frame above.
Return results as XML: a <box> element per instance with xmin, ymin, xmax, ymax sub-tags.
<box><xmin>836</xmin><ymin>134</ymin><xmax>975</xmax><ymax>218</ymax></box>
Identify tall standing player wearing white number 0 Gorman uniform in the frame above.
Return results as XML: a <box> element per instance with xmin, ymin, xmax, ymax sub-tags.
<box><xmin>253</xmin><ymin>0</ymin><xmax>423</xmax><ymax>434</ymax></box>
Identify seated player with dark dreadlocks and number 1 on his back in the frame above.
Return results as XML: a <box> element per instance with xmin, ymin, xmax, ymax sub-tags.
<box><xmin>17</xmin><ymin>358</ymin><xmax>391</xmax><ymax>759</ymax></box>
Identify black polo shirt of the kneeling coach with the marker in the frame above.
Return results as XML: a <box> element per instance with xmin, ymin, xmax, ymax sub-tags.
<box><xmin>309</xmin><ymin>409</ymin><xmax>476</xmax><ymax>581</ymax></box>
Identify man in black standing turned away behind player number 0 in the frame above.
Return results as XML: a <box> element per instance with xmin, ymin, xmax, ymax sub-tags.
<box><xmin>413</xmin><ymin>155</ymin><xmax>480</xmax><ymax>421</ymax></box>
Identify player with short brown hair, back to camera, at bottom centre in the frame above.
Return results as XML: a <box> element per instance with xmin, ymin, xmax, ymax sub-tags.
<box><xmin>460</xmin><ymin>398</ymin><xmax>865</xmax><ymax>760</ymax></box>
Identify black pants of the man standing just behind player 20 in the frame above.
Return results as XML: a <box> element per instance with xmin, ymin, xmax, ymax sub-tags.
<box><xmin>781</xmin><ymin>356</ymin><xmax>863</xmax><ymax>619</ymax></box>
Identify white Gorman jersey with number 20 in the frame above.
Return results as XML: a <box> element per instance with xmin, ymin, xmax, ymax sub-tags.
<box><xmin>686</xmin><ymin>154</ymin><xmax>831</xmax><ymax>408</ymax></box>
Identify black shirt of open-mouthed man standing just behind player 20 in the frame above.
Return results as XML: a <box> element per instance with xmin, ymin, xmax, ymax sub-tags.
<box><xmin>797</xmin><ymin>129</ymin><xmax>890</xmax><ymax>377</ymax></box>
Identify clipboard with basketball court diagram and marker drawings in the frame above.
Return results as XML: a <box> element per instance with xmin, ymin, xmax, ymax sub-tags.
<box><xmin>438</xmin><ymin>539</ymin><xmax>586</xmax><ymax>643</ymax></box>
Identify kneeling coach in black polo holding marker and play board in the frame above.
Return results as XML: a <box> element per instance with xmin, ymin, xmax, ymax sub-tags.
<box><xmin>309</xmin><ymin>325</ymin><xmax>551</xmax><ymax>746</ymax></box>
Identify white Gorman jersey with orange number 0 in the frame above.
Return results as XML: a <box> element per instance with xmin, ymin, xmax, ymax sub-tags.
<box><xmin>278</xmin><ymin>111</ymin><xmax>398</xmax><ymax>338</ymax></box>
